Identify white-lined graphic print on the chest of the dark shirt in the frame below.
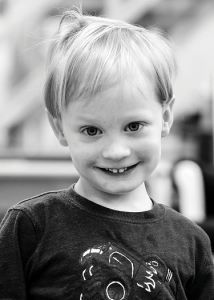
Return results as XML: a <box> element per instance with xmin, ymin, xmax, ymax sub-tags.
<box><xmin>80</xmin><ymin>243</ymin><xmax>175</xmax><ymax>300</ymax></box>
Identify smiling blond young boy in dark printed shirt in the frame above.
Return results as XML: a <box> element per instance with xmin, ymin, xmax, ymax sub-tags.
<box><xmin>0</xmin><ymin>5</ymin><xmax>214</xmax><ymax>300</ymax></box>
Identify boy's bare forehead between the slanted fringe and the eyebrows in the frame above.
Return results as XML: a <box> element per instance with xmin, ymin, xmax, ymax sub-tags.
<box><xmin>63</xmin><ymin>77</ymin><xmax>157</xmax><ymax>119</ymax></box>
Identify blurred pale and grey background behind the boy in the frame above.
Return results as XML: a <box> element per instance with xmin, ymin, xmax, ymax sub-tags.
<box><xmin>0</xmin><ymin>0</ymin><xmax>214</xmax><ymax>245</ymax></box>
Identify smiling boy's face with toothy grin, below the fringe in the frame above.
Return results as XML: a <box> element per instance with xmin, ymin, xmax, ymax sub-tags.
<box><xmin>50</xmin><ymin>77</ymin><xmax>172</xmax><ymax>199</ymax></box>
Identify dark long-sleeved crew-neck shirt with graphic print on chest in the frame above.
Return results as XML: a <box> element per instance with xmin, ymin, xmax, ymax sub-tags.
<box><xmin>0</xmin><ymin>187</ymin><xmax>214</xmax><ymax>300</ymax></box>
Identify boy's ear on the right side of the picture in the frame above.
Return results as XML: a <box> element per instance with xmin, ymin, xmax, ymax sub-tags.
<box><xmin>161</xmin><ymin>97</ymin><xmax>175</xmax><ymax>137</ymax></box>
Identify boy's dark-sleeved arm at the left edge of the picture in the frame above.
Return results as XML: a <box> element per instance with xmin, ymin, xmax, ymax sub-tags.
<box><xmin>0</xmin><ymin>210</ymin><xmax>37</xmax><ymax>300</ymax></box>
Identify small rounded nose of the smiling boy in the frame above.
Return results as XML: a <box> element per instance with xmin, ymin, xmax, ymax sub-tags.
<box><xmin>102</xmin><ymin>143</ymin><xmax>131</xmax><ymax>160</ymax></box>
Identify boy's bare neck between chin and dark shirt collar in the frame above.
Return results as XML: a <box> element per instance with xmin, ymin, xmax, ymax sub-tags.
<box><xmin>74</xmin><ymin>181</ymin><xmax>153</xmax><ymax>212</ymax></box>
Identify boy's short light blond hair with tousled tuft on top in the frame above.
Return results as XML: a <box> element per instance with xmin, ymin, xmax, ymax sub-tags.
<box><xmin>44</xmin><ymin>8</ymin><xmax>177</xmax><ymax>118</ymax></box>
